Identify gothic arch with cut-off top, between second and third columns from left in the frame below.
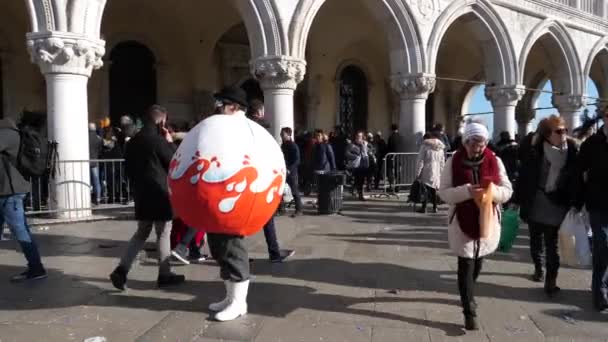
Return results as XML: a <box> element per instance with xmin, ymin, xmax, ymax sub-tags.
<box><xmin>289</xmin><ymin>0</ymin><xmax>426</xmax><ymax>74</ymax></box>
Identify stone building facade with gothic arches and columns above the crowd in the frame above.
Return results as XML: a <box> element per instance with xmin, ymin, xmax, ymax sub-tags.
<box><xmin>0</xmin><ymin>0</ymin><xmax>608</xmax><ymax>216</ymax></box>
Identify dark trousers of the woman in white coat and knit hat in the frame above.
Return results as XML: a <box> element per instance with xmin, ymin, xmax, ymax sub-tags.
<box><xmin>458</xmin><ymin>257</ymin><xmax>483</xmax><ymax>317</ymax></box>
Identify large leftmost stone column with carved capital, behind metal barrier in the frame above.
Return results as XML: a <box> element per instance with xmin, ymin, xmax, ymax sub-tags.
<box><xmin>27</xmin><ymin>32</ymin><xmax>105</xmax><ymax>219</ymax></box>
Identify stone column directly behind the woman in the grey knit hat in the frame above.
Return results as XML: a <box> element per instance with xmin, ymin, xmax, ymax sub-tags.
<box><xmin>485</xmin><ymin>85</ymin><xmax>526</xmax><ymax>139</ymax></box>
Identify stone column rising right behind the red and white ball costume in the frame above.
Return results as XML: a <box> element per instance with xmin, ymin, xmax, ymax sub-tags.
<box><xmin>251</xmin><ymin>56</ymin><xmax>306</xmax><ymax>141</ymax></box>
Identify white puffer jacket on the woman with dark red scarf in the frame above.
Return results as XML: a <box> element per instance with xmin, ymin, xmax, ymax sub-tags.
<box><xmin>439</xmin><ymin>157</ymin><xmax>513</xmax><ymax>259</ymax></box>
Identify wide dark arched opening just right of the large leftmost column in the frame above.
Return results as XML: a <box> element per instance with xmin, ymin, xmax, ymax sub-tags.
<box><xmin>110</xmin><ymin>41</ymin><xmax>156</xmax><ymax>123</ymax></box>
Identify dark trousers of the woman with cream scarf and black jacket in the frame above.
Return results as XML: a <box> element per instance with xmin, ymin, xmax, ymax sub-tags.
<box><xmin>528</xmin><ymin>222</ymin><xmax>559</xmax><ymax>280</ymax></box>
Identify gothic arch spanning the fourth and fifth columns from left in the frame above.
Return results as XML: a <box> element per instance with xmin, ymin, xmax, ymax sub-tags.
<box><xmin>519</xmin><ymin>19</ymin><xmax>586</xmax><ymax>95</ymax></box>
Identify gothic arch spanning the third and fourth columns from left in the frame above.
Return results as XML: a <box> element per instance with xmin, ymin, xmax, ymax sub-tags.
<box><xmin>427</xmin><ymin>0</ymin><xmax>519</xmax><ymax>85</ymax></box>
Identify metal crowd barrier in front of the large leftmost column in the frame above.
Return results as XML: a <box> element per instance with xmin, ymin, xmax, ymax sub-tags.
<box><xmin>25</xmin><ymin>159</ymin><xmax>133</xmax><ymax>218</ymax></box>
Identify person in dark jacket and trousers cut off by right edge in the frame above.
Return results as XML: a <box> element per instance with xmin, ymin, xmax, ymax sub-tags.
<box><xmin>576</xmin><ymin>111</ymin><xmax>608</xmax><ymax>312</ymax></box>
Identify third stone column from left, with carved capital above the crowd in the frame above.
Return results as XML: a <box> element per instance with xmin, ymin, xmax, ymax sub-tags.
<box><xmin>391</xmin><ymin>74</ymin><xmax>435</xmax><ymax>152</ymax></box>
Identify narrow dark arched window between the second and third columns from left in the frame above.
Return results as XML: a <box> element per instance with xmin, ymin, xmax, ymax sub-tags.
<box><xmin>339</xmin><ymin>65</ymin><xmax>368</xmax><ymax>134</ymax></box>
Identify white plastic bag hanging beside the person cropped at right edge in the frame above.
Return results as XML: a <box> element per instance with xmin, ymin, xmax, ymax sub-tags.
<box><xmin>560</xmin><ymin>209</ymin><xmax>591</xmax><ymax>266</ymax></box>
